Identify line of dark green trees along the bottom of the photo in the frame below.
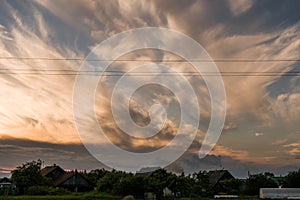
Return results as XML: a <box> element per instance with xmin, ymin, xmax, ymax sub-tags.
<box><xmin>0</xmin><ymin>160</ymin><xmax>300</xmax><ymax>199</ymax></box>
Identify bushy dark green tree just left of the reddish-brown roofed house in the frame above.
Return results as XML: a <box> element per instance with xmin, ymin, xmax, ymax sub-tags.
<box><xmin>11</xmin><ymin>160</ymin><xmax>51</xmax><ymax>194</ymax></box>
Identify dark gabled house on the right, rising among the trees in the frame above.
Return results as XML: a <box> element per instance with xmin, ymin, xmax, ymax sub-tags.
<box><xmin>207</xmin><ymin>170</ymin><xmax>234</xmax><ymax>193</ymax></box>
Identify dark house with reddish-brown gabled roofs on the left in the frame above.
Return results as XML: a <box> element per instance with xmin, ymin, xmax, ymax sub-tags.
<box><xmin>41</xmin><ymin>165</ymin><xmax>93</xmax><ymax>192</ymax></box>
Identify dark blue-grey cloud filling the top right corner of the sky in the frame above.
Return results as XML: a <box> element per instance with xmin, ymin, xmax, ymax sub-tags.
<box><xmin>154</xmin><ymin>0</ymin><xmax>300</xmax><ymax>40</ymax></box>
